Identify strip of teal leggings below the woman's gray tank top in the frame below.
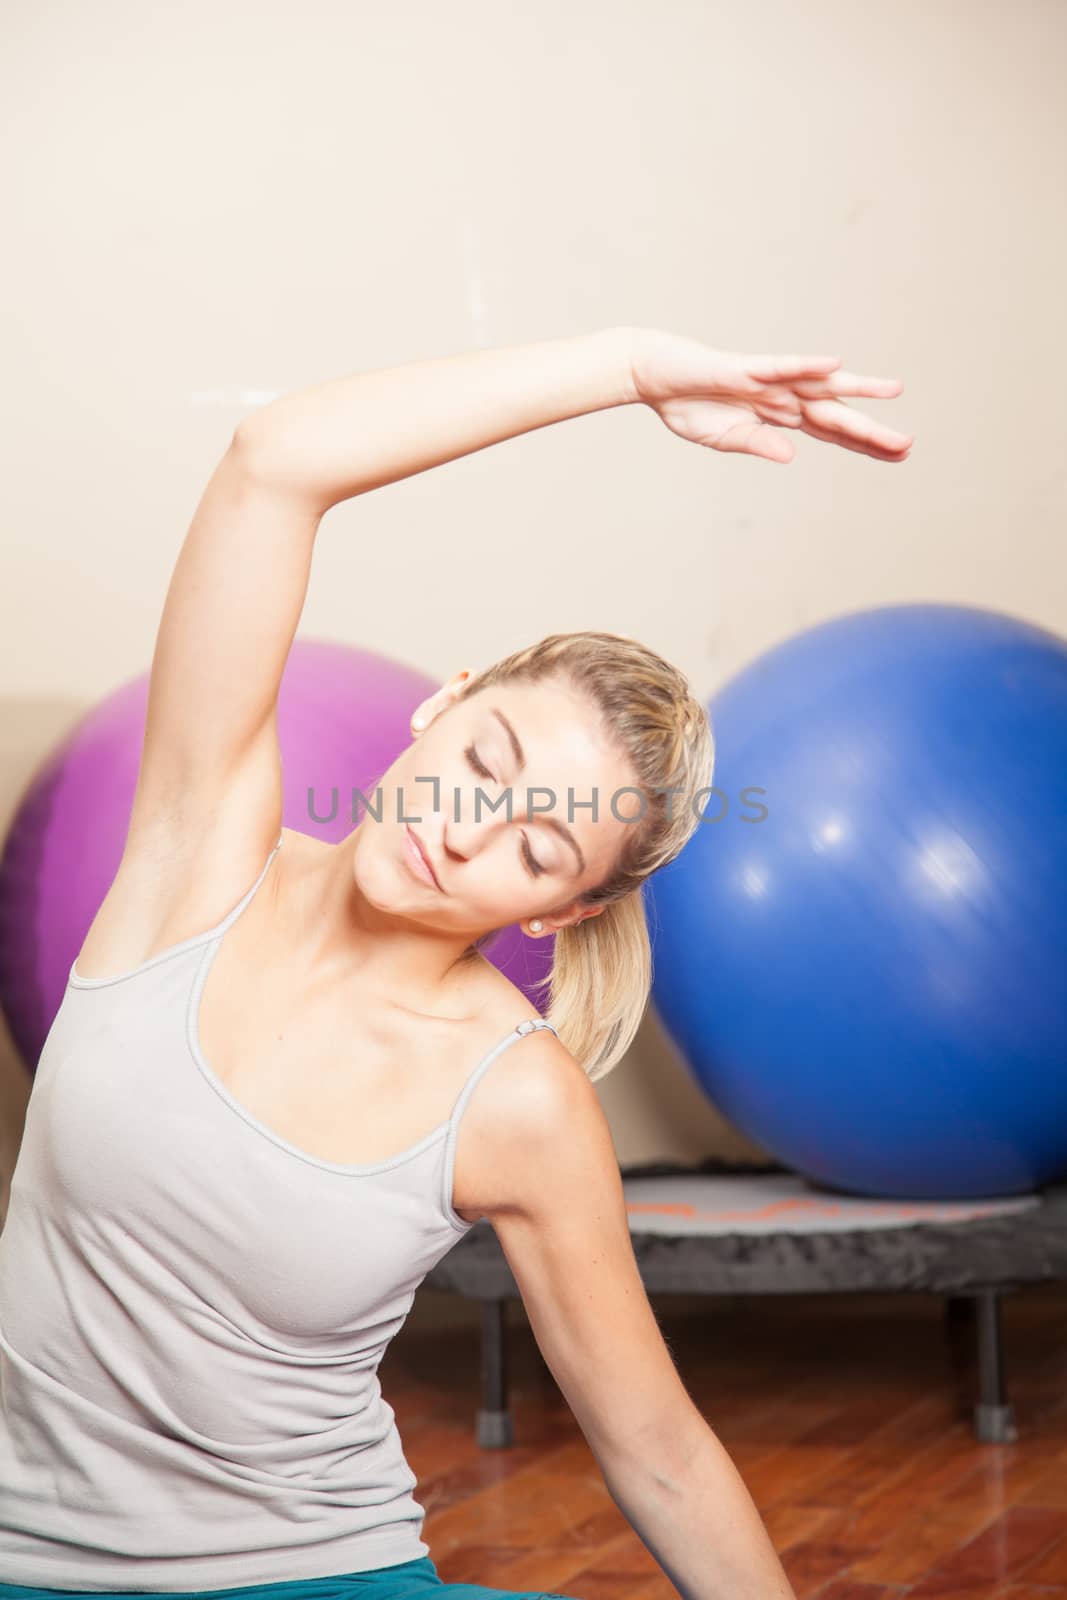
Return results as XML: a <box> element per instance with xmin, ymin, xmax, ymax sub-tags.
<box><xmin>0</xmin><ymin>1555</ymin><xmax>568</xmax><ymax>1600</ymax></box>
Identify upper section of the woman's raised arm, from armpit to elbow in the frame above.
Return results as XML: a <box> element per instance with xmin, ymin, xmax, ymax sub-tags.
<box><xmin>125</xmin><ymin>441</ymin><xmax>320</xmax><ymax>893</ymax></box>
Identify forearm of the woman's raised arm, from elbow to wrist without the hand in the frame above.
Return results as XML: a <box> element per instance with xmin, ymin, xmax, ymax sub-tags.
<box><xmin>238</xmin><ymin>326</ymin><xmax>637</xmax><ymax>510</ymax></box>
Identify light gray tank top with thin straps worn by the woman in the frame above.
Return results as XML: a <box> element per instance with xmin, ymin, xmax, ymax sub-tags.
<box><xmin>0</xmin><ymin>838</ymin><xmax>555</xmax><ymax>1594</ymax></box>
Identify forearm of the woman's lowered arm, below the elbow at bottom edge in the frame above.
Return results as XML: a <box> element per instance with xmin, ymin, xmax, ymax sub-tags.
<box><xmin>601</xmin><ymin>1414</ymin><xmax>797</xmax><ymax>1600</ymax></box>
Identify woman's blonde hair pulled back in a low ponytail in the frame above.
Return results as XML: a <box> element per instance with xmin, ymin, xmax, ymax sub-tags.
<box><xmin>462</xmin><ymin>632</ymin><xmax>715</xmax><ymax>1082</ymax></box>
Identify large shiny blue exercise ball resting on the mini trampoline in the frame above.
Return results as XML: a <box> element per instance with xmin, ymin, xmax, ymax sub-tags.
<box><xmin>646</xmin><ymin>605</ymin><xmax>1067</xmax><ymax>1198</ymax></box>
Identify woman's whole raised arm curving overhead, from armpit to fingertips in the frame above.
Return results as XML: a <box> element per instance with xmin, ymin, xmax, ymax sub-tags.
<box><xmin>126</xmin><ymin>316</ymin><xmax>910</xmax><ymax>893</ymax></box>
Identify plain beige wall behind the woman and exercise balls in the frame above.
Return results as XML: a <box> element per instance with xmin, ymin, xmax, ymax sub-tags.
<box><xmin>0</xmin><ymin>0</ymin><xmax>1067</xmax><ymax>1203</ymax></box>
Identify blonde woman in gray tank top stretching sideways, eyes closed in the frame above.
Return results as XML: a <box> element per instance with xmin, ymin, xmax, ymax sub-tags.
<box><xmin>0</xmin><ymin>328</ymin><xmax>910</xmax><ymax>1600</ymax></box>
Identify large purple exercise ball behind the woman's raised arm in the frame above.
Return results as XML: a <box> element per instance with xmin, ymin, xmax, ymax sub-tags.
<box><xmin>0</xmin><ymin>638</ymin><xmax>552</xmax><ymax>1070</ymax></box>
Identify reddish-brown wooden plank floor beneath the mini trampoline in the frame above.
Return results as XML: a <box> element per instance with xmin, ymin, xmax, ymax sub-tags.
<box><xmin>388</xmin><ymin>1285</ymin><xmax>1067</xmax><ymax>1600</ymax></box>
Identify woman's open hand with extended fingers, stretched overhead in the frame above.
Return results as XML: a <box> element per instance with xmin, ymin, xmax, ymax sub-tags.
<box><xmin>630</xmin><ymin>328</ymin><xmax>912</xmax><ymax>462</ymax></box>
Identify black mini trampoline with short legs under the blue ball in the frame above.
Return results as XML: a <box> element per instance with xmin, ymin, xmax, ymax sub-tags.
<box><xmin>422</xmin><ymin>1158</ymin><xmax>1067</xmax><ymax>1450</ymax></box>
